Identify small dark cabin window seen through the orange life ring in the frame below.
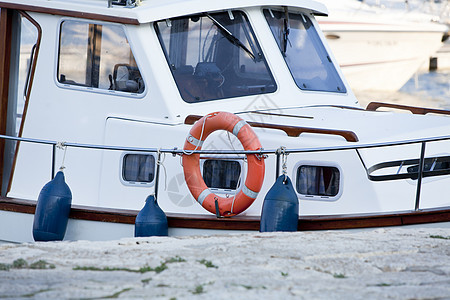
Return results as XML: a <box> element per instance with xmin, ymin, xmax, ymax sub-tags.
<box><xmin>203</xmin><ymin>159</ymin><xmax>241</xmax><ymax>190</ymax></box>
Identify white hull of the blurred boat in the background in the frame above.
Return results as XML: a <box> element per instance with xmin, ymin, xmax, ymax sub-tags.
<box><xmin>322</xmin><ymin>27</ymin><xmax>442</xmax><ymax>91</ymax></box>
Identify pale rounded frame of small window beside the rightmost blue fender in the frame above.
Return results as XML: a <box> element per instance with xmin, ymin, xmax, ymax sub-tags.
<box><xmin>292</xmin><ymin>160</ymin><xmax>344</xmax><ymax>202</ymax></box>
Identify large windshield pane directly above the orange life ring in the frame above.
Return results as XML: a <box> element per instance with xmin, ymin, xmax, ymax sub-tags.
<box><xmin>155</xmin><ymin>11</ymin><xmax>276</xmax><ymax>103</ymax></box>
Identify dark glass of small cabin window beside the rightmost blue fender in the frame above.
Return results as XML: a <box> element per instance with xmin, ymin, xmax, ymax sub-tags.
<box><xmin>296</xmin><ymin>165</ymin><xmax>340</xmax><ymax>197</ymax></box>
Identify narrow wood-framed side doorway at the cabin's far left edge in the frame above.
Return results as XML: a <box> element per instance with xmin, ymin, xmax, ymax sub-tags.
<box><xmin>0</xmin><ymin>8</ymin><xmax>42</xmax><ymax>195</ymax></box>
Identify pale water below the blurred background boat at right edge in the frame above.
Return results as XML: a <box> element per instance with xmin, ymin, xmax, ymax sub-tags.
<box><xmin>355</xmin><ymin>69</ymin><xmax>450</xmax><ymax>110</ymax></box>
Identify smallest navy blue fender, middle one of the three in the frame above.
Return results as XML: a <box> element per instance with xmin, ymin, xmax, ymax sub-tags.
<box><xmin>134</xmin><ymin>195</ymin><xmax>169</xmax><ymax>237</ymax></box>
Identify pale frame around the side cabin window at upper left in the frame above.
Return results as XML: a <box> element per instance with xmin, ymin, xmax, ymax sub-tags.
<box><xmin>53</xmin><ymin>17</ymin><xmax>148</xmax><ymax>99</ymax></box>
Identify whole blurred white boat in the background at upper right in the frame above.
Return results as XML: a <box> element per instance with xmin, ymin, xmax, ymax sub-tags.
<box><xmin>318</xmin><ymin>0</ymin><xmax>448</xmax><ymax>91</ymax></box>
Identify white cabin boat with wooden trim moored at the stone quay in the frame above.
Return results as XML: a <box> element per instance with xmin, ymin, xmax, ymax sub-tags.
<box><xmin>0</xmin><ymin>0</ymin><xmax>450</xmax><ymax>242</ymax></box>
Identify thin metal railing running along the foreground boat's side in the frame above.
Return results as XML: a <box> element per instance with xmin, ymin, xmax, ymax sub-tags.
<box><xmin>0</xmin><ymin>135</ymin><xmax>450</xmax><ymax>210</ymax></box>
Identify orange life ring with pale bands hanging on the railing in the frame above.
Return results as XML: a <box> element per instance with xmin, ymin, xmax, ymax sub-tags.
<box><xmin>183</xmin><ymin>112</ymin><xmax>265</xmax><ymax>217</ymax></box>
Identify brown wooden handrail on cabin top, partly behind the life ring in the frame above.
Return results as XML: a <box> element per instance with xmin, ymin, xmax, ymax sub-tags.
<box><xmin>184</xmin><ymin>115</ymin><xmax>359</xmax><ymax>143</ymax></box>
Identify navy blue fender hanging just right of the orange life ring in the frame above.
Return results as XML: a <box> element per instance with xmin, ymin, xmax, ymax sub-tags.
<box><xmin>259</xmin><ymin>175</ymin><xmax>299</xmax><ymax>232</ymax></box>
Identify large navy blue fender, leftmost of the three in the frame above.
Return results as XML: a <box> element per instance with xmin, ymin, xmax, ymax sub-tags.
<box><xmin>33</xmin><ymin>171</ymin><xmax>72</xmax><ymax>242</ymax></box>
